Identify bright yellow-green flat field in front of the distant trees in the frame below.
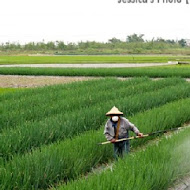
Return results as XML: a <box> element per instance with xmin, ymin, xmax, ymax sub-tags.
<box><xmin>0</xmin><ymin>55</ymin><xmax>190</xmax><ymax>64</ymax></box>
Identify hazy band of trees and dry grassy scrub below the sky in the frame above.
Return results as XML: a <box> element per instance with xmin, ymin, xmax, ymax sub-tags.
<box><xmin>0</xmin><ymin>34</ymin><xmax>190</xmax><ymax>55</ymax></box>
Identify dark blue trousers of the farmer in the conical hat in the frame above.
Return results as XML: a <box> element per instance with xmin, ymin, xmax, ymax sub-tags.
<box><xmin>114</xmin><ymin>141</ymin><xmax>130</xmax><ymax>160</ymax></box>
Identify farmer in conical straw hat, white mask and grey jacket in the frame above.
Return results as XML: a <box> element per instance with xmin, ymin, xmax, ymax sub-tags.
<box><xmin>104</xmin><ymin>106</ymin><xmax>143</xmax><ymax>160</ymax></box>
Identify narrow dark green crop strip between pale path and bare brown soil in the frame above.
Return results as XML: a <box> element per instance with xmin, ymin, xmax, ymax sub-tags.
<box><xmin>0</xmin><ymin>66</ymin><xmax>190</xmax><ymax>78</ymax></box>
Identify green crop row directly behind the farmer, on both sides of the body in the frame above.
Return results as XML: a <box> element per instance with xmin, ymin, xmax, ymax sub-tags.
<box><xmin>0</xmin><ymin>98</ymin><xmax>190</xmax><ymax>189</ymax></box>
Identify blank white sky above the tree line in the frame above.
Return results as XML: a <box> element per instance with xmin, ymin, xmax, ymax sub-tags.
<box><xmin>0</xmin><ymin>0</ymin><xmax>190</xmax><ymax>43</ymax></box>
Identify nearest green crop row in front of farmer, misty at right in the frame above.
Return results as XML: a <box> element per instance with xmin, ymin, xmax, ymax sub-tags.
<box><xmin>56</xmin><ymin>128</ymin><xmax>190</xmax><ymax>190</ymax></box>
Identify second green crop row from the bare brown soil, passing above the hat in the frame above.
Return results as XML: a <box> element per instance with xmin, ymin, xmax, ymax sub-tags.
<box><xmin>0</xmin><ymin>79</ymin><xmax>181</xmax><ymax>130</ymax></box>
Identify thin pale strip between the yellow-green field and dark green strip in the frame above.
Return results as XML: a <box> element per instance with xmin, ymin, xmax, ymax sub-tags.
<box><xmin>0</xmin><ymin>62</ymin><xmax>177</xmax><ymax>68</ymax></box>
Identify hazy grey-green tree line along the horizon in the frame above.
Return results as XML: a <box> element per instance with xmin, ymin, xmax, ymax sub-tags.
<box><xmin>0</xmin><ymin>34</ymin><xmax>188</xmax><ymax>53</ymax></box>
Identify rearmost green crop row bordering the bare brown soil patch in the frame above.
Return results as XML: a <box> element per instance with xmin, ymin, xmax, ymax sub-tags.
<box><xmin>1</xmin><ymin>78</ymin><xmax>126</xmax><ymax>105</ymax></box>
